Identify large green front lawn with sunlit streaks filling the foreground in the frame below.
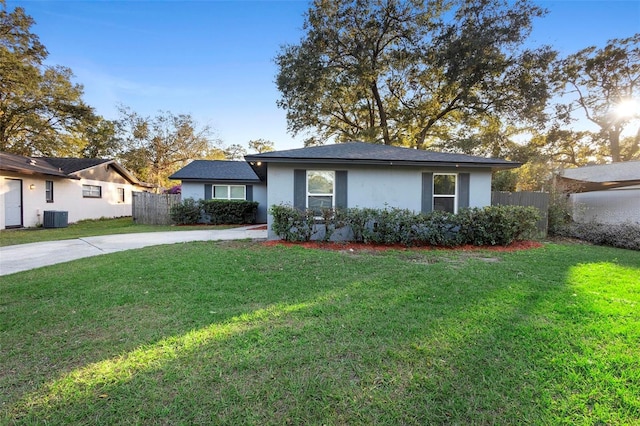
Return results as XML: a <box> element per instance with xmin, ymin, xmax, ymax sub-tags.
<box><xmin>0</xmin><ymin>242</ymin><xmax>640</xmax><ymax>425</ymax></box>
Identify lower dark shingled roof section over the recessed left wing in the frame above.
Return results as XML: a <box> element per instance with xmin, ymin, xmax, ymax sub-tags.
<box><xmin>169</xmin><ymin>160</ymin><xmax>260</xmax><ymax>182</ymax></box>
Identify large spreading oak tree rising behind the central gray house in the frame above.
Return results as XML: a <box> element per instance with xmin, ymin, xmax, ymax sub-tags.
<box><xmin>276</xmin><ymin>0</ymin><xmax>554</xmax><ymax>148</ymax></box>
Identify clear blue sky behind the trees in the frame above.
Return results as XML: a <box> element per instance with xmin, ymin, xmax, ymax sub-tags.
<box><xmin>7</xmin><ymin>0</ymin><xmax>640</xmax><ymax>149</ymax></box>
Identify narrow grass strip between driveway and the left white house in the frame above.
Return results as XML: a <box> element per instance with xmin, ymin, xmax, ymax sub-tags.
<box><xmin>0</xmin><ymin>217</ymin><xmax>235</xmax><ymax>247</ymax></box>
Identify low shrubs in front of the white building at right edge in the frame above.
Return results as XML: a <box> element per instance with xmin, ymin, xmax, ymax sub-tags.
<box><xmin>556</xmin><ymin>222</ymin><xmax>640</xmax><ymax>250</ymax></box>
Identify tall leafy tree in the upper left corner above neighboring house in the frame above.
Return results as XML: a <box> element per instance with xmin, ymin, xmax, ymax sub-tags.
<box><xmin>0</xmin><ymin>0</ymin><xmax>98</xmax><ymax>156</ymax></box>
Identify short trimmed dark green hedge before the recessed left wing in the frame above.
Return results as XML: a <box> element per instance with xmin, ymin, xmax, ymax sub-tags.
<box><xmin>171</xmin><ymin>198</ymin><xmax>258</xmax><ymax>225</ymax></box>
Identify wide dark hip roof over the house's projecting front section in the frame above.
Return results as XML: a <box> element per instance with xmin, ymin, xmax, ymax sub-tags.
<box><xmin>245</xmin><ymin>142</ymin><xmax>521</xmax><ymax>168</ymax></box>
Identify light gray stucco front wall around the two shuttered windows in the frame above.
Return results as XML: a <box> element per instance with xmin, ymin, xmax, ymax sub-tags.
<box><xmin>267</xmin><ymin>163</ymin><xmax>491</xmax><ymax>238</ymax></box>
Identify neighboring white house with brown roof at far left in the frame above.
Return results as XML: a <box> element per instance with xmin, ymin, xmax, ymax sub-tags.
<box><xmin>0</xmin><ymin>152</ymin><xmax>151</xmax><ymax>229</ymax></box>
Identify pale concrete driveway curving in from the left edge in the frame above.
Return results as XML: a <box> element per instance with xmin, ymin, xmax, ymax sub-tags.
<box><xmin>0</xmin><ymin>225</ymin><xmax>267</xmax><ymax>275</ymax></box>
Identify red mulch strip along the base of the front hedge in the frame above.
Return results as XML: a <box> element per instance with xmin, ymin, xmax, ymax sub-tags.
<box><xmin>263</xmin><ymin>240</ymin><xmax>542</xmax><ymax>252</ymax></box>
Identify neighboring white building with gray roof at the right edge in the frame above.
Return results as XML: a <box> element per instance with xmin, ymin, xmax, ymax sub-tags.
<box><xmin>558</xmin><ymin>161</ymin><xmax>640</xmax><ymax>224</ymax></box>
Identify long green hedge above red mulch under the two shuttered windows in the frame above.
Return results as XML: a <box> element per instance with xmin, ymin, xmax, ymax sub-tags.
<box><xmin>269</xmin><ymin>205</ymin><xmax>540</xmax><ymax>246</ymax></box>
